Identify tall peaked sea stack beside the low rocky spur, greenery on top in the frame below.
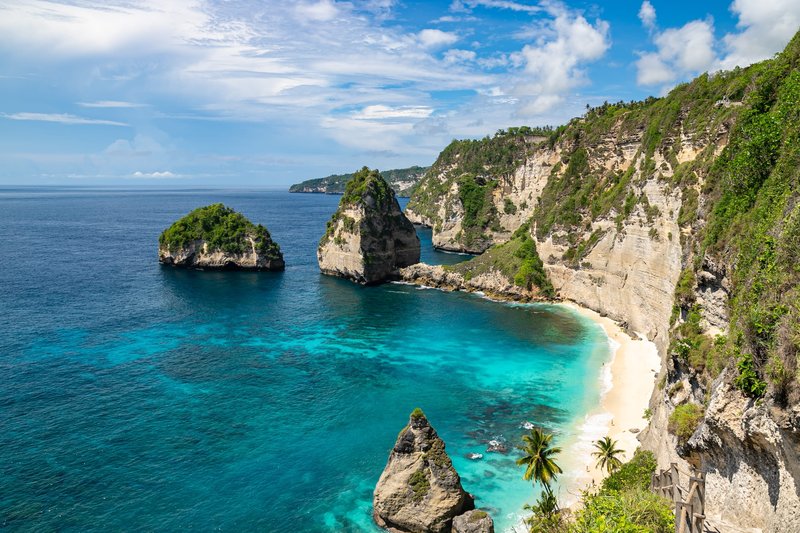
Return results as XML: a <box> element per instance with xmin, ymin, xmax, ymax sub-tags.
<box><xmin>317</xmin><ymin>167</ymin><xmax>419</xmax><ymax>285</ymax></box>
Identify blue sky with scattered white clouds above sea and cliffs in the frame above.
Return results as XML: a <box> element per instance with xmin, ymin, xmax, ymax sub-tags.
<box><xmin>0</xmin><ymin>0</ymin><xmax>800</xmax><ymax>188</ymax></box>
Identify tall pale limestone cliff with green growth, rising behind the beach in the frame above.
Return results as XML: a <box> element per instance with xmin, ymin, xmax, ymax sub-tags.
<box><xmin>409</xmin><ymin>33</ymin><xmax>800</xmax><ymax>532</ymax></box>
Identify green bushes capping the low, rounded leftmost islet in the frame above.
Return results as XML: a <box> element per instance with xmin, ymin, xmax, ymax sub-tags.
<box><xmin>158</xmin><ymin>204</ymin><xmax>280</xmax><ymax>258</ymax></box>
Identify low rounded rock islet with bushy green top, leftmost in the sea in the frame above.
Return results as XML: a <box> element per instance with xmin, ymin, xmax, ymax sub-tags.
<box><xmin>158</xmin><ymin>204</ymin><xmax>285</xmax><ymax>270</ymax></box>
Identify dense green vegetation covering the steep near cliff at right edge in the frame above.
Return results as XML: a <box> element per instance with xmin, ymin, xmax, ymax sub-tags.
<box><xmin>673</xmin><ymin>29</ymin><xmax>800</xmax><ymax>406</ymax></box>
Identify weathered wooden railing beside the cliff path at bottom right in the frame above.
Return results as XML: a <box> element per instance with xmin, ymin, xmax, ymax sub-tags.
<box><xmin>650</xmin><ymin>463</ymin><xmax>706</xmax><ymax>533</ymax></box>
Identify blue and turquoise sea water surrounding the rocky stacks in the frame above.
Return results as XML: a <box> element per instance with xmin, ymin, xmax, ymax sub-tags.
<box><xmin>0</xmin><ymin>189</ymin><xmax>609</xmax><ymax>532</ymax></box>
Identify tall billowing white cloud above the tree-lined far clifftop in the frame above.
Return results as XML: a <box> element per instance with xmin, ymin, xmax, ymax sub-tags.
<box><xmin>513</xmin><ymin>5</ymin><xmax>611</xmax><ymax>116</ymax></box>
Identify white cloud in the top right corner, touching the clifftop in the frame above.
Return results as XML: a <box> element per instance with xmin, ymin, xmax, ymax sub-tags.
<box><xmin>719</xmin><ymin>0</ymin><xmax>800</xmax><ymax>69</ymax></box>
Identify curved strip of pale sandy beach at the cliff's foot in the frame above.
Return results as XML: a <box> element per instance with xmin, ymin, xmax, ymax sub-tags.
<box><xmin>559</xmin><ymin>301</ymin><xmax>661</xmax><ymax>508</ymax></box>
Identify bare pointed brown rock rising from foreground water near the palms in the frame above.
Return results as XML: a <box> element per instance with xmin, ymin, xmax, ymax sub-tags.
<box><xmin>372</xmin><ymin>409</ymin><xmax>484</xmax><ymax>533</ymax></box>
